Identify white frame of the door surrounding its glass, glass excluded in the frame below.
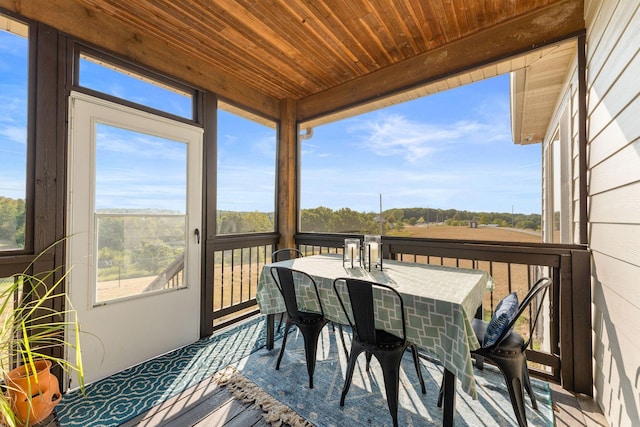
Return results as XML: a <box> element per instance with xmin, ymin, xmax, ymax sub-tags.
<box><xmin>67</xmin><ymin>92</ymin><xmax>203</xmax><ymax>388</ymax></box>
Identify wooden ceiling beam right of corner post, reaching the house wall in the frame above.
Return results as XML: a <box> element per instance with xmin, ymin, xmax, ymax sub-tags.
<box><xmin>297</xmin><ymin>0</ymin><xmax>585</xmax><ymax>121</ymax></box>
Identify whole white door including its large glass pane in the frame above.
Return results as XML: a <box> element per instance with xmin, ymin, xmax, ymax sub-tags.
<box><xmin>67</xmin><ymin>93</ymin><xmax>202</xmax><ymax>388</ymax></box>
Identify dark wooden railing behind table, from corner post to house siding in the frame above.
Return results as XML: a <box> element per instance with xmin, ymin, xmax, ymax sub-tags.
<box><xmin>296</xmin><ymin>233</ymin><xmax>592</xmax><ymax>393</ymax></box>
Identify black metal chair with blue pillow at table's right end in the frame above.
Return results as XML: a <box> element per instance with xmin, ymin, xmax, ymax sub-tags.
<box><xmin>438</xmin><ymin>277</ymin><xmax>553</xmax><ymax>427</ymax></box>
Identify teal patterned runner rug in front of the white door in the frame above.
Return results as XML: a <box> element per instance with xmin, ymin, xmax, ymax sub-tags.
<box><xmin>56</xmin><ymin>316</ymin><xmax>266</xmax><ymax>427</ymax></box>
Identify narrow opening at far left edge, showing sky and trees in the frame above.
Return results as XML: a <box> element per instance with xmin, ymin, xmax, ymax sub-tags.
<box><xmin>0</xmin><ymin>15</ymin><xmax>29</xmax><ymax>251</ymax></box>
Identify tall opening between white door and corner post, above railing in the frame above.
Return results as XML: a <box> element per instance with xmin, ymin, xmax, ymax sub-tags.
<box><xmin>216</xmin><ymin>109</ymin><xmax>276</xmax><ymax>234</ymax></box>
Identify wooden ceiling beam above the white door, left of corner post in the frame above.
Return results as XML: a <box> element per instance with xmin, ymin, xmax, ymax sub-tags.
<box><xmin>0</xmin><ymin>0</ymin><xmax>280</xmax><ymax>119</ymax></box>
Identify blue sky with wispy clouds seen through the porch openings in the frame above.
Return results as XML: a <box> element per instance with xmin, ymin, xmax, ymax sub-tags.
<box><xmin>0</xmin><ymin>26</ymin><xmax>541</xmax><ymax>217</ymax></box>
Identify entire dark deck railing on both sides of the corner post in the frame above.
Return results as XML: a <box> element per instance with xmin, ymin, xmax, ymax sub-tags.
<box><xmin>207</xmin><ymin>233</ymin><xmax>592</xmax><ymax>393</ymax></box>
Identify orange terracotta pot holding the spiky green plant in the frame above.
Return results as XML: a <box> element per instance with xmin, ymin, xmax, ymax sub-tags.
<box><xmin>5</xmin><ymin>360</ymin><xmax>62</xmax><ymax>426</ymax></box>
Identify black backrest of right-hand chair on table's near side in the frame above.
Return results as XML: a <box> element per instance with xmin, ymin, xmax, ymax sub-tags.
<box><xmin>333</xmin><ymin>277</ymin><xmax>406</xmax><ymax>345</ymax></box>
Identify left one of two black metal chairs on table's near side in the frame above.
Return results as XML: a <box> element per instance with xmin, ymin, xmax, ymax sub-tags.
<box><xmin>270</xmin><ymin>267</ymin><xmax>329</xmax><ymax>388</ymax></box>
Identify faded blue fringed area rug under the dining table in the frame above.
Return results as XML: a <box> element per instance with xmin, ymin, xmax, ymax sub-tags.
<box><xmin>228</xmin><ymin>327</ymin><xmax>553</xmax><ymax>427</ymax></box>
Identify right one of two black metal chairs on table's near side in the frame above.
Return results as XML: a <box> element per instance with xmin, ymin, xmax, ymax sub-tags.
<box><xmin>333</xmin><ymin>278</ymin><xmax>427</xmax><ymax>426</ymax></box>
